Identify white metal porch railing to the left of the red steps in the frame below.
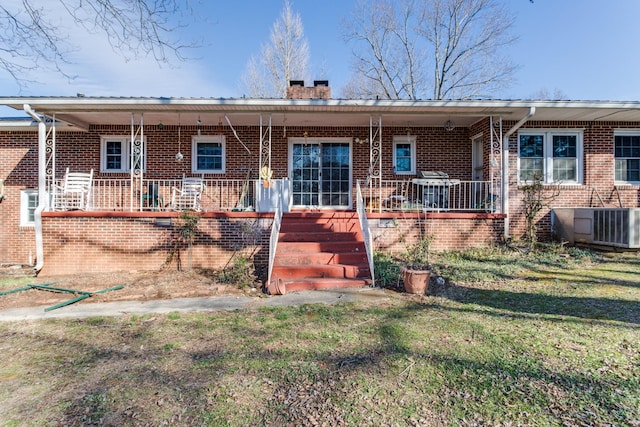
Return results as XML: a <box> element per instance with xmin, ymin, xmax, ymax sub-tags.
<box><xmin>50</xmin><ymin>178</ymin><xmax>255</xmax><ymax>212</ymax></box>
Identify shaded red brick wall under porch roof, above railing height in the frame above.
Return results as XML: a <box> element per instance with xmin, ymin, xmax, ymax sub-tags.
<box><xmin>0</xmin><ymin>125</ymin><xmax>471</xmax><ymax>185</ymax></box>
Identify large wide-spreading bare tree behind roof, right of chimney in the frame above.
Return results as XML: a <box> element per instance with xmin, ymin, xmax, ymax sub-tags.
<box><xmin>345</xmin><ymin>0</ymin><xmax>515</xmax><ymax>99</ymax></box>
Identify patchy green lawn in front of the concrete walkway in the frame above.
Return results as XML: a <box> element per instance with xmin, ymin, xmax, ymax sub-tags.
<box><xmin>0</xmin><ymin>248</ymin><xmax>640</xmax><ymax>426</ymax></box>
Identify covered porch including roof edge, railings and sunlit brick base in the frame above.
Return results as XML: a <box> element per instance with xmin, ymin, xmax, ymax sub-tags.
<box><xmin>3</xmin><ymin>98</ymin><xmax>519</xmax><ymax>278</ymax></box>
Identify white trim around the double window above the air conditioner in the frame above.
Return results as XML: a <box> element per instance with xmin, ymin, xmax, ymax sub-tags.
<box><xmin>516</xmin><ymin>129</ymin><xmax>584</xmax><ymax>185</ymax></box>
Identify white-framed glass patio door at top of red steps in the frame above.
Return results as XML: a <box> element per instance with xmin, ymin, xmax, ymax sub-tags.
<box><xmin>291</xmin><ymin>142</ymin><xmax>351</xmax><ymax>209</ymax></box>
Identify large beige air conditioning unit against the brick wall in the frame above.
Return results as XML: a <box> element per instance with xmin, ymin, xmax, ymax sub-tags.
<box><xmin>551</xmin><ymin>208</ymin><xmax>640</xmax><ymax>249</ymax></box>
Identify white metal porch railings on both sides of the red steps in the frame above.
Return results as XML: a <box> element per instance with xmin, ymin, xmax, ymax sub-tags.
<box><xmin>48</xmin><ymin>178</ymin><xmax>499</xmax><ymax>213</ymax></box>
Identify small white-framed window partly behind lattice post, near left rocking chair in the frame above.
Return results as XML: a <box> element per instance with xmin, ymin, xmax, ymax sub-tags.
<box><xmin>100</xmin><ymin>135</ymin><xmax>146</xmax><ymax>173</ymax></box>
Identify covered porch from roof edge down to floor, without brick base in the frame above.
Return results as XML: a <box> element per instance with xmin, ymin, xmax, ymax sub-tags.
<box><xmin>25</xmin><ymin>99</ymin><xmax>513</xmax><ymax>217</ymax></box>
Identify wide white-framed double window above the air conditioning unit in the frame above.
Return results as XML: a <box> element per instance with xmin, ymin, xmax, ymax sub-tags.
<box><xmin>518</xmin><ymin>130</ymin><xmax>582</xmax><ymax>184</ymax></box>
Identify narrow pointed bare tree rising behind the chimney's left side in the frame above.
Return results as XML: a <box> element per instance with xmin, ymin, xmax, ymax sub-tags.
<box><xmin>242</xmin><ymin>0</ymin><xmax>310</xmax><ymax>98</ymax></box>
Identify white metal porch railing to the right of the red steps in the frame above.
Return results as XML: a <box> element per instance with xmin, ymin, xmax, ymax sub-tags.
<box><xmin>362</xmin><ymin>179</ymin><xmax>498</xmax><ymax>213</ymax></box>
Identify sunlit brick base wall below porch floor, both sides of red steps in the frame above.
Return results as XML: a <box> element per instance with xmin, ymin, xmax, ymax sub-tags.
<box><xmin>35</xmin><ymin>212</ymin><xmax>504</xmax><ymax>277</ymax></box>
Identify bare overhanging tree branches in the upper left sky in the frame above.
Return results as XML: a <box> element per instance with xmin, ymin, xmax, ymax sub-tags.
<box><xmin>0</xmin><ymin>0</ymin><xmax>194</xmax><ymax>86</ymax></box>
